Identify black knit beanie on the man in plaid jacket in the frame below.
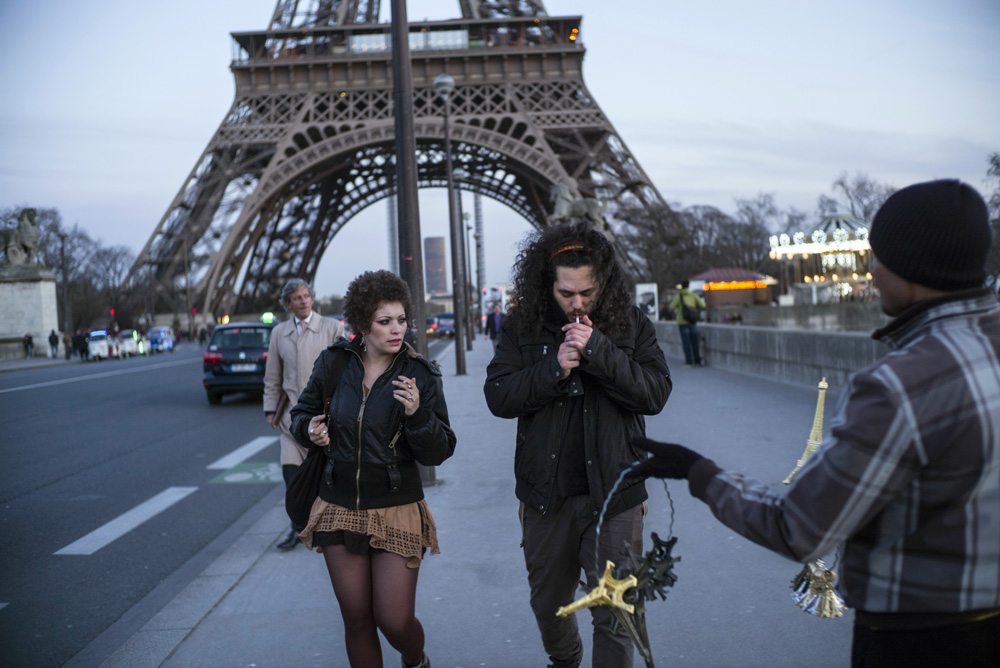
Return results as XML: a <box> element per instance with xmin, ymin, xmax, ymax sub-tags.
<box><xmin>868</xmin><ymin>179</ymin><xmax>991</xmax><ymax>291</ymax></box>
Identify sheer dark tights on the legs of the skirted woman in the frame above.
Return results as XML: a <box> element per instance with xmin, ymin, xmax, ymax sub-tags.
<box><xmin>323</xmin><ymin>545</ymin><xmax>424</xmax><ymax>668</ymax></box>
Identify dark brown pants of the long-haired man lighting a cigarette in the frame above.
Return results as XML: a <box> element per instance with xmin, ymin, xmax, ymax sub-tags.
<box><xmin>521</xmin><ymin>496</ymin><xmax>644</xmax><ymax>668</ymax></box>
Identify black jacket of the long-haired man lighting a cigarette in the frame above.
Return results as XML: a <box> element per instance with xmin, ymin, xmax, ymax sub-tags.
<box><xmin>483</xmin><ymin>306</ymin><xmax>673</xmax><ymax>516</ymax></box>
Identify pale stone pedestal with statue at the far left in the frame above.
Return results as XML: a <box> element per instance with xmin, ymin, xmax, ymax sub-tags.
<box><xmin>0</xmin><ymin>209</ymin><xmax>60</xmax><ymax>358</ymax></box>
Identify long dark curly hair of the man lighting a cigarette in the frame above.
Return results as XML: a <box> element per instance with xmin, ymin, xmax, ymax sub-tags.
<box><xmin>510</xmin><ymin>222</ymin><xmax>632</xmax><ymax>338</ymax></box>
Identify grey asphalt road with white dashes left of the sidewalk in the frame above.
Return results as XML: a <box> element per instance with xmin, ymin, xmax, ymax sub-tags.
<box><xmin>0</xmin><ymin>341</ymin><xmax>447</xmax><ymax>668</ymax></box>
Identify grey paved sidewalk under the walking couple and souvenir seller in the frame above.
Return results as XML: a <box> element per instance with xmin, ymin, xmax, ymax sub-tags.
<box><xmin>82</xmin><ymin>339</ymin><xmax>852</xmax><ymax>668</ymax></box>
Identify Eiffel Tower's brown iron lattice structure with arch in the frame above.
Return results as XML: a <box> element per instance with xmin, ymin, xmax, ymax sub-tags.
<box><xmin>131</xmin><ymin>0</ymin><xmax>663</xmax><ymax>316</ymax></box>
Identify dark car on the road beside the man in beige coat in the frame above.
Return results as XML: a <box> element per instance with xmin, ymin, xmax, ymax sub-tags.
<box><xmin>203</xmin><ymin>322</ymin><xmax>274</xmax><ymax>404</ymax></box>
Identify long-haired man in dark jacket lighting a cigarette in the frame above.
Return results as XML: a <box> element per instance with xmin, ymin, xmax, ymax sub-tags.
<box><xmin>484</xmin><ymin>223</ymin><xmax>672</xmax><ymax>668</ymax></box>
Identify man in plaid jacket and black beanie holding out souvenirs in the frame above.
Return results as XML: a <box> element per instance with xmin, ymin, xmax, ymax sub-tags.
<box><xmin>632</xmin><ymin>180</ymin><xmax>1000</xmax><ymax>668</ymax></box>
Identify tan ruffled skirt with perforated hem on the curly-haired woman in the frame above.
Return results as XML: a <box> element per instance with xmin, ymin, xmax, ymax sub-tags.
<box><xmin>299</xmin><ymin>497</ymin><xmax>441</xmax><ymax>568</ymax></box>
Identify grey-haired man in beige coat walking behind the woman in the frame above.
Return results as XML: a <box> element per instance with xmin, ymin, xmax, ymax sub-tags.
<box><xmin>264</xmin><ymin>278</ymin><xmax>346</xmax><ymax>550</ymax></box>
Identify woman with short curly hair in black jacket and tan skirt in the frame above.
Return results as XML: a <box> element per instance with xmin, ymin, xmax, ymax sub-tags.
<box><xmin>292</xmin><ymin>271</ymin><xmax>455</xmax><ymax>668</ymax></box>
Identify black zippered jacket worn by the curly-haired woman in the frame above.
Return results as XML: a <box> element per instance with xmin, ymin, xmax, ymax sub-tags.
<box><xmin>291</xmin><ymin>337</ymin><xmax>455</xmax><ymax>509</ymax></box>
